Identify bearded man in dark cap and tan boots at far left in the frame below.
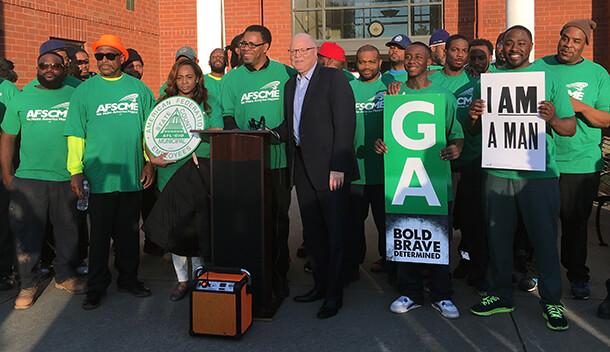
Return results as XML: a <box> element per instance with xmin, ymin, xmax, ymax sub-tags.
<box><xmin>0</xmin><ymin>48</ymin><xmax>85</xmax><ymax>309</ymax></box>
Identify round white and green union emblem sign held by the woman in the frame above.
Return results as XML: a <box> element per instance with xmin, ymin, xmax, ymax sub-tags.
<box><xmin>144</xmin><ymin>96</ymin><xmax>204</xmax><ymax>160</ymax></box>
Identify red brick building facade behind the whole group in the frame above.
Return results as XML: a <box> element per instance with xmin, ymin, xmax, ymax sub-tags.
<box><xmin>0</xmin><ymin>0</ymin><xmax>610</xmax><ymax>92</ymax></box>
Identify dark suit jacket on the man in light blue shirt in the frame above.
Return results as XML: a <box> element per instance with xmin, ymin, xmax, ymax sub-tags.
<box><xmin>276</xmin><ymin>64</ymin><xmax>360</xmax><ymax>190</ymax></box>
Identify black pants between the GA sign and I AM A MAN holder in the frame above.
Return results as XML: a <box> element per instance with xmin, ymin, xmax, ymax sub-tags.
<box><xmin>454</xmin><ymin>159</ymin><xmax>489</xmax><ymax>285</ymax></box>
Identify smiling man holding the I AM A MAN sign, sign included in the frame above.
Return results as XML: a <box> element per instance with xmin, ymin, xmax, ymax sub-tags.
<box><xmin>470</xmin><ymin>26</ymin><xmax>576</xmax><ymax>331</ymax></box>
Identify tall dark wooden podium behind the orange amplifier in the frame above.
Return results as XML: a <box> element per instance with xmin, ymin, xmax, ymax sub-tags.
<box><xmin>192</xmin><ymin>130</ymin><xmax>281</xmax><ymax>319</ymax></box>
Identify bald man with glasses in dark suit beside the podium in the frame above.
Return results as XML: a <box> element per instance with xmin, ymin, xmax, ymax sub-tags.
<box><xmin>276</xmin><ymin>33</ymin><xmax>358</xmax><ymax>319</ymax></box>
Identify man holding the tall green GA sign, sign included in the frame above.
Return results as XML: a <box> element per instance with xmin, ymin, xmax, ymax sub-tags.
<box><xmin>375</xmin><ymin>42</ymin><xmax>464</xmax><ymax>319</ymax></box>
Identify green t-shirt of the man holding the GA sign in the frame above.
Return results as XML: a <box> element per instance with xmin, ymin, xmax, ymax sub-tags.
<box><xmin>398</xmin><ymin>82</ymin><xmax>464</xmax><ymax>201</ymax></box>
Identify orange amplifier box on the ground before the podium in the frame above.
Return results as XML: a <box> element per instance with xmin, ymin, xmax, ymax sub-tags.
<box><xmin>190</xmin><ymin>267</ymin><xmax>252</xmax><ymax>337</ymax></box>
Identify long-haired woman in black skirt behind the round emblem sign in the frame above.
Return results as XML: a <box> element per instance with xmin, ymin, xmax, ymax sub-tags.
<box><xmin>143</xmin><ymin>58</ymin><xmax>221</xmax><ymax>301</ymax></box>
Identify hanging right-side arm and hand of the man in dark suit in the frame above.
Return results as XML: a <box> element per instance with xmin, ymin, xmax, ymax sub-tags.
<box><xmin>329</xmin><ymin>71</ymin><xmax>356</xmax><ymax>191</ymax></box>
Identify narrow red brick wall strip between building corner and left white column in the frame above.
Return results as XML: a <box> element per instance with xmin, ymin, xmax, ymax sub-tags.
<box><xmin>154</xmin><ymin>0</ymin><xmax>196</xmax><ymax>94</ymax></box>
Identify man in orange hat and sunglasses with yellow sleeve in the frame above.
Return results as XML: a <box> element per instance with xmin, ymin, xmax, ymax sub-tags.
<box><xmin>64</xmin><ymin>34</ymin><xmax>155</xmax><ymax>310</ymax></box>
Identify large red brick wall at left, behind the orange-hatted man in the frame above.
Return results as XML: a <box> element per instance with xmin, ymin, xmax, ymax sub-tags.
<box><xmin>0</xmin><ymin>0</ymin><xmax>160</xmax><ymax>89</ymax></box>
